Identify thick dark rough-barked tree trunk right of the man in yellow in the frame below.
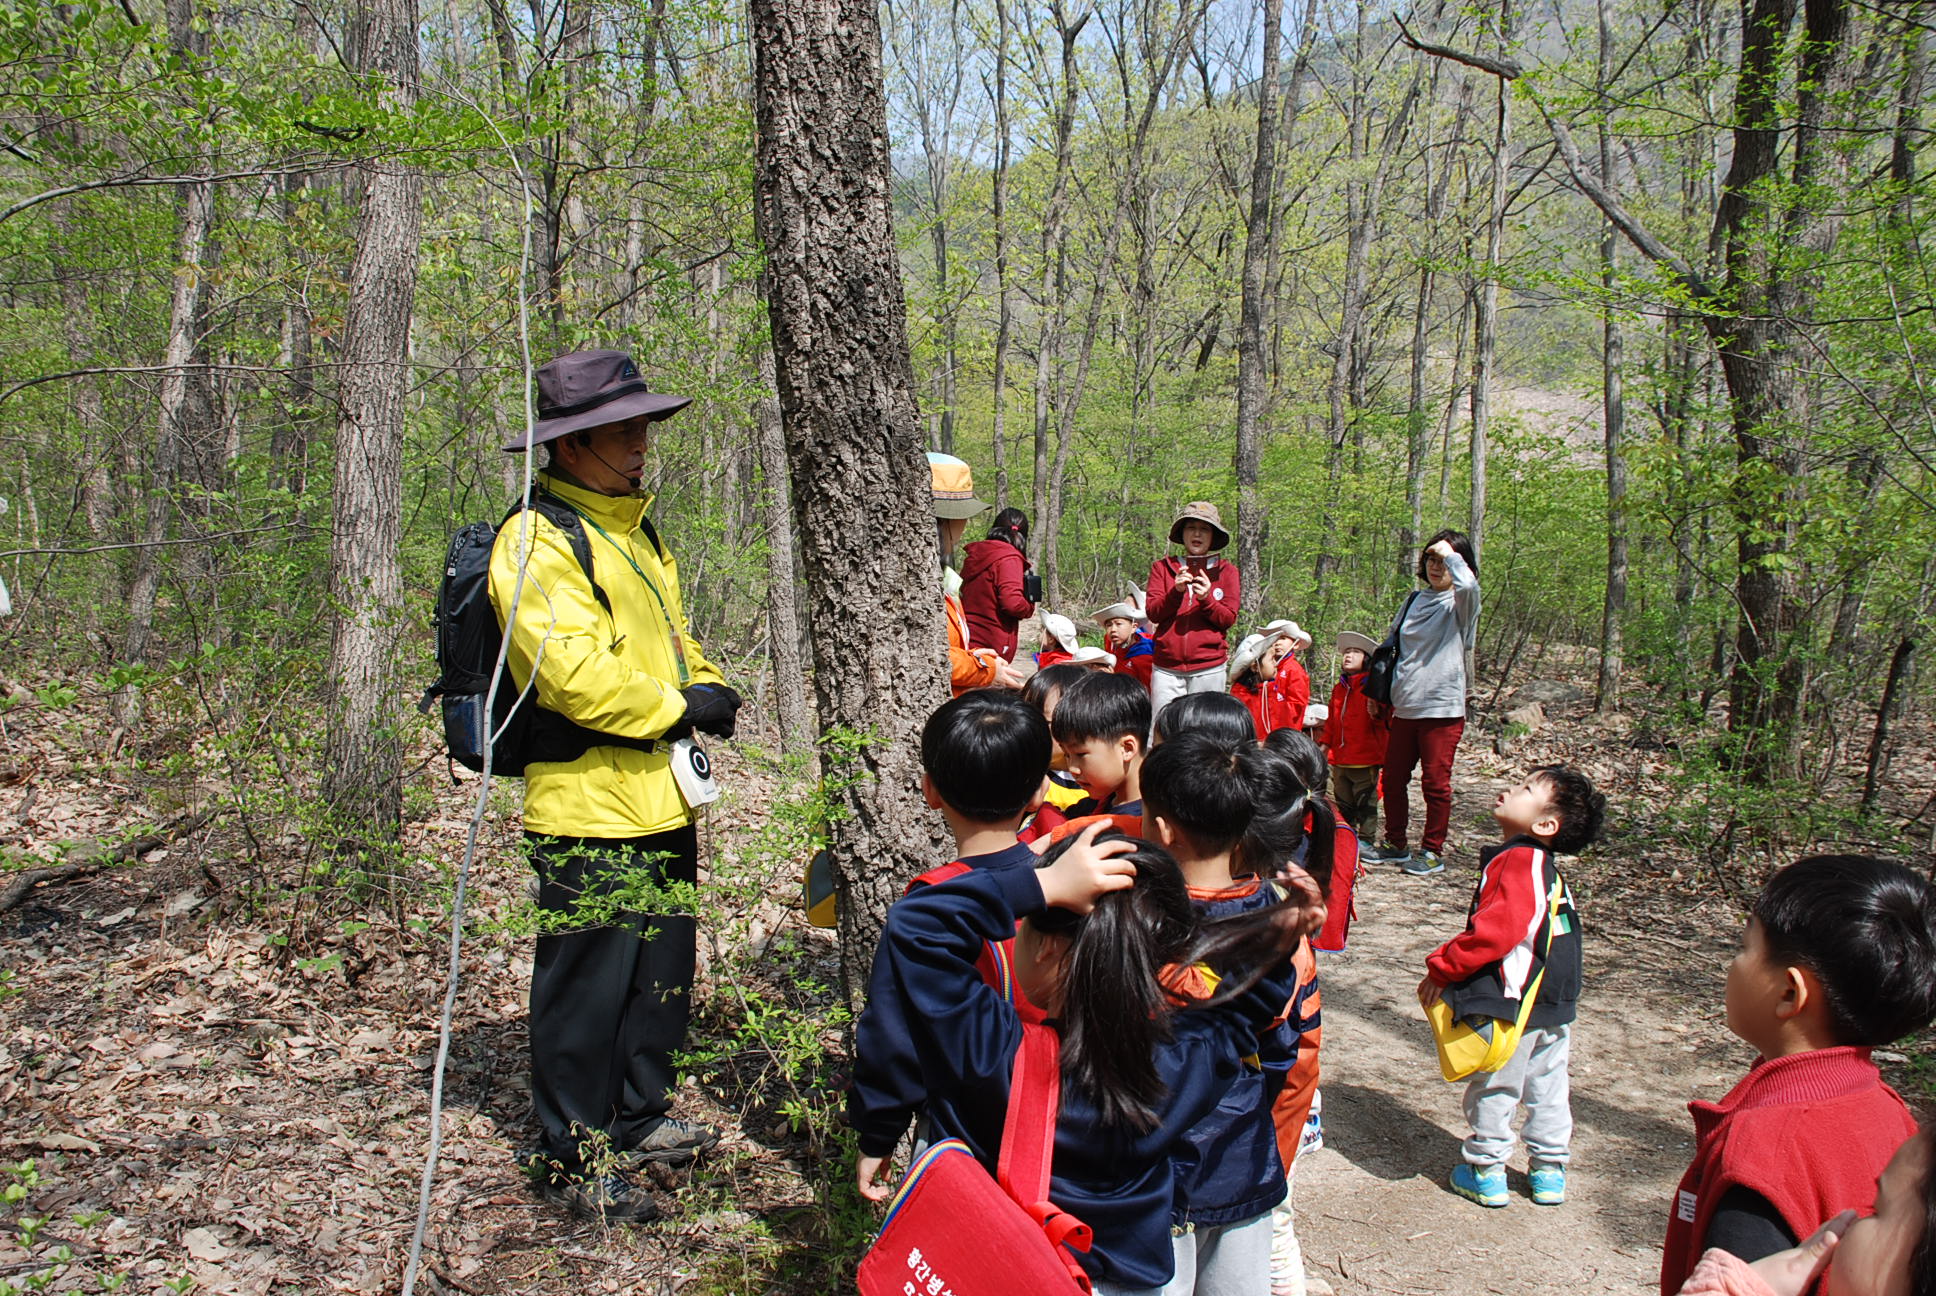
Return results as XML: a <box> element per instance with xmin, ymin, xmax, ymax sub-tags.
<box><xmin>751</xmin><ymin>0</ymin><xmax>949</xmax><ymax>964</ymax></box>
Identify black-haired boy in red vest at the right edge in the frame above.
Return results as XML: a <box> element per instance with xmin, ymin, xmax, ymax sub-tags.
<box><xmin>1661</xmin><ymin>854</ymin><xmax>1936</xmax><ymax>1296</ymax></box>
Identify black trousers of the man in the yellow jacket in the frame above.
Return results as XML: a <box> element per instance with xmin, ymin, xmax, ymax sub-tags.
<box><xmin>527</xmin><ymin>825</ymin><xmax>699</xmax><ymax>1174</ymax></box>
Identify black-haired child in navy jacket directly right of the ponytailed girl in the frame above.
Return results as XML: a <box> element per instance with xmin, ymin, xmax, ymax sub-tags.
<box><xmin>1142</xmin><ymin>732</ymin><xmax>1297</xmax><ymax>1294</ymax></box>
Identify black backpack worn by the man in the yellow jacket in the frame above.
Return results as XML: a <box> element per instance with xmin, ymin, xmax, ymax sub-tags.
<box><xmin>416</xmin><ymin>490</ymin><xmax>658</xmax><ymax>779</ymax></box>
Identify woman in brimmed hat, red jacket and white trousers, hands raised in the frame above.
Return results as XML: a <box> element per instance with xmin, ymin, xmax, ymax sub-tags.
<box><xmin>1146</xmin><ymin>500</ymin><xmax>1243</xmax><ymax>713</ymax></box>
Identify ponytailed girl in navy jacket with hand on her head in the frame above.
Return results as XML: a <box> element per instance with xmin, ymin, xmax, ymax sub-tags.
<box><xmin>858</xmin><ymin>829</ymin><xmax>1316</xmax><ymax>1296</ymax></box>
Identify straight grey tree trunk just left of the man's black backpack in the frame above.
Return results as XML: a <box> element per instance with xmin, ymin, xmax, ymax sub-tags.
<box><xmin>323</xmin><ymin>0</ymin><xmax>424</xmax><ymax>843</ymax></box>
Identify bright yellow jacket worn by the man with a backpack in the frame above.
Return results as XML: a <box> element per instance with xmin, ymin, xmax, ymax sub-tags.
<box><xmin>490</xmin><ymin>473</ymin><xmax>724</xmax><ymax>837</ymax></box>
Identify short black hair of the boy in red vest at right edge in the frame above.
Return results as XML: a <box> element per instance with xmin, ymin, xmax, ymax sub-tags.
<box><xmin>1754</xmin><ymin>854</ymin><xmax>1936</xmax><ymax>1048</ymax></box>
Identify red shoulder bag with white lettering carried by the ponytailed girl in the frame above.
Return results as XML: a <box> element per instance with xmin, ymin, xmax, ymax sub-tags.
<box><xmin>860</xmin><ymin>1025</ymin><xmax>1092</xmax><ymax>1296</ymax></box>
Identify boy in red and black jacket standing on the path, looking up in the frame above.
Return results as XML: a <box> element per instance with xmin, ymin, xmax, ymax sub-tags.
<box><xmin>1419</xmin><ymin>765</ymin><xmax>1607</xmax><ymax>1207</ymax></box>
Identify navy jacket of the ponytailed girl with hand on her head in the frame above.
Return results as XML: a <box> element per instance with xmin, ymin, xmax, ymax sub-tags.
<box><xmin>869</xmin><ymin>868</ymin><xmax>1295</xmax><ymax>1286</ymax></box>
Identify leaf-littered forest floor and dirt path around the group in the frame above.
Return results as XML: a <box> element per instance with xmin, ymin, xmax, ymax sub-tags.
<box><xmin>0</xmin><ymin>666</ymin><xmax>1936</xmax><ymax>1296</ymax></box>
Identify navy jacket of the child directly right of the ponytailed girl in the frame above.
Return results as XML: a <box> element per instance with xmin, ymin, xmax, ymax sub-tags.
<box><xmin>1171</xmin><ymin>878</ymin><xmax>1297</xmax><ymax>1226</ymax></box>
